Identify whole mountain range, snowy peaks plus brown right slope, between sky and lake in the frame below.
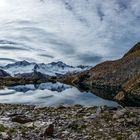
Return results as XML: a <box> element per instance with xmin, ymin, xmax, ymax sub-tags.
<box><xmin>0</xmin><ymin>43</ymin><xmax>140</xmax><ymax>106</ymax></box>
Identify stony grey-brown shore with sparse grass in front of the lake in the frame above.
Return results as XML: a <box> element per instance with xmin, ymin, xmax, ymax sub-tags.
<box><xmin>0</xmin><ymin>104</ymin><xmax>140</xmax><ymax>140</ymax></box>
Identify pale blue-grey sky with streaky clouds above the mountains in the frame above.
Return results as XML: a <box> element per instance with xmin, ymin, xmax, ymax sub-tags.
<box><xmin>0</xmin><ymin>0</ymin><xmax>140</xmax><ymax>65</ymax></box>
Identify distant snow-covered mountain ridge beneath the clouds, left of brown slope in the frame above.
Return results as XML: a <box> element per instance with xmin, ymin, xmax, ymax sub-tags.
<box><xmin>2</xmin><ymin>60</ymin><xmax>87</xmax><ymax>76</ymax></box>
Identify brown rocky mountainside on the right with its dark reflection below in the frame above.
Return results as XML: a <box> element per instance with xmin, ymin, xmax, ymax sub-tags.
<box><xmin>64</xmin><ymin>43</ymin><xmax>140</xmax><ymax>104</ymax></box>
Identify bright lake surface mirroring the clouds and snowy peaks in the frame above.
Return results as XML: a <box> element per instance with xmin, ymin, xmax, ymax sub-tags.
<box><xmin>0</xmin><ymin>83</ymin><xmax>118</xmax><ymax>106</ymax></box>
